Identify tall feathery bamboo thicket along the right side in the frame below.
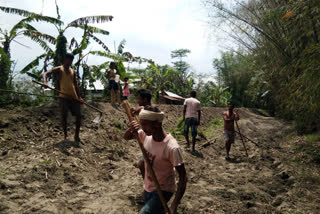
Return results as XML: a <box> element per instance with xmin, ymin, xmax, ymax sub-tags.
<box><xmin>205</xmin><ymin>0</ymin><xmax>320</xmax><ymax>133</ymax></box>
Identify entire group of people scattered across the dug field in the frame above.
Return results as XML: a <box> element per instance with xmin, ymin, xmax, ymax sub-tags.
<box><xmin>43</xmin><ymin>54</ymin><xmax>239</xmax><ymax>214</ymax></box>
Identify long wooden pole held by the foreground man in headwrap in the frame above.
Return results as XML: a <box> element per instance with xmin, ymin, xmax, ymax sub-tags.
<box><xmin>122</xmin><ymin>100</ymin><xmax>170</xmax><ymax>214</ymax></box>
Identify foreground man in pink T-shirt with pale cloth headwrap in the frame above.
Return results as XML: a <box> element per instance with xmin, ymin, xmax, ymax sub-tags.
<box><xmin>124</xmin><ymin>106</ymin><xmax>187</xmax><ymax>214</ymax></box>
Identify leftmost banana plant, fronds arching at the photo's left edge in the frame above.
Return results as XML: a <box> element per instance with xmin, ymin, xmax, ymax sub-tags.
<box><xmin>0</xmin><ymin>7</ymin><xmax>61</xmax><ymax>88</ymax></box>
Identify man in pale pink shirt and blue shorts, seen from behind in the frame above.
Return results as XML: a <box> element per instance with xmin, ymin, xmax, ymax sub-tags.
<box><xmin>183</xmin><ymin>91</ymin><xmax>201</xmax><ymax>152</ymax></box>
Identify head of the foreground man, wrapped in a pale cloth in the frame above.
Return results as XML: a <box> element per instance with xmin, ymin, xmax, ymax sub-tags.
<box><xmin>139</xmin><ymin>106</ymin><xmax>164</xmax><ymax>136</ymax></box>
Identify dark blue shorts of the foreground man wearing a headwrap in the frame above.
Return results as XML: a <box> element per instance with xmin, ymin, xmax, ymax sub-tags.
<box><xmin>140</xmin><ymin>191</ymin><xmax>173</xmax><ymax>214</ymax></box>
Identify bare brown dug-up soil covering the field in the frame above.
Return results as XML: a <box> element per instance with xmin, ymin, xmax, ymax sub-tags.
<box><xmin>0</xmin><ymin>103</ymin><xmax>320</xmax><ymax>214</ymax></box>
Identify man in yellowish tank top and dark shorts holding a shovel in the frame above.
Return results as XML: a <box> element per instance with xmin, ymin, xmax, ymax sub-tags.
<box><xmin>43</xmin><ymin>53</ymin><xmax>84</xmax><ymax>142</ymax></box>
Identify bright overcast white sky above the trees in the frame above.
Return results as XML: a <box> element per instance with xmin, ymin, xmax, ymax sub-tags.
<box><xmin>0</xmin><ymin>0</ymin><xmax>223</xmax><ymax>74</ymax></box>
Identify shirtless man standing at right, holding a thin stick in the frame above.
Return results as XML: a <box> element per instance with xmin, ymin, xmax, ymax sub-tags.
<box><xmin>223</xmin><ymin>103</ymin><xmax>239</xmax><ymax>160</ymax></box>
